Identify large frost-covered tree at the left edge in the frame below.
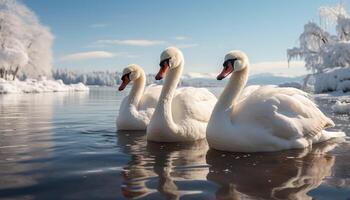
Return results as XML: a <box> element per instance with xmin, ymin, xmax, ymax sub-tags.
<box><xmin>0</xmin><ymin>0</ymin><xmax>53</xmax><ymax>78</ymax></box>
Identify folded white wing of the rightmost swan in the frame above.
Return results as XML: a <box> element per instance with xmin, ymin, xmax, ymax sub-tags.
<box><xmin>232</xmin><ymin>86</ymin><xmax>334</xmax><ymax>139</ymax></box>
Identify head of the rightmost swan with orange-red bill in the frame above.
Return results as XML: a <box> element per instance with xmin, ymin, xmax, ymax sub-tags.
<box><xmin>216</xmin><ymin>51</ymin><xmax>249</xmax><ymax>80</ymax></box>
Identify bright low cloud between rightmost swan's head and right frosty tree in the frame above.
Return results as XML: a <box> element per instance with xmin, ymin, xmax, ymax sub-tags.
<box><xmin>250</xmin><ymin>61</ymin><xmax>307</xmax><ymax>76</ymax></box>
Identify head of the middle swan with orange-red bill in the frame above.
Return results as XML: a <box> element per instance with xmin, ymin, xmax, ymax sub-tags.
<box><xmin>155</xmin><ymin>47</ymin><xmax>184</xmax><ymax>80</ymax></box>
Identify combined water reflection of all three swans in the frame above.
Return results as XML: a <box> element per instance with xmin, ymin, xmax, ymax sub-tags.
<box><xmin>118</xmin><ymin>132</ymin><xmax>337</xmax><ymax>199</ymax></box>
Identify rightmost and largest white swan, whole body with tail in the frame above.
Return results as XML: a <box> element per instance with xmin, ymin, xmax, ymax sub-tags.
<box><xmin>207</xmin><ymin>51</ymin><xmax>344</xmax><ymax>152</ymax></box>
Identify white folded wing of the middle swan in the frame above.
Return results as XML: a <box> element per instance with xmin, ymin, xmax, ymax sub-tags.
<box><xmin>172</xmin><ymin>87</ymin><xmax>217</xmax><ymax>123</ymax></box>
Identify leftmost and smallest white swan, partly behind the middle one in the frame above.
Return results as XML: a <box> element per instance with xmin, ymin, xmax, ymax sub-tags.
<box><xmin>117</xmin><ymin>64</ymin><xmax>162</xmax><ymax>130</ymax></box>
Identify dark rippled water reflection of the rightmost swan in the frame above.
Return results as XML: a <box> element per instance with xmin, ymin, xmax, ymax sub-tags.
<box><xmin>207</xmin><ymin>141</ymin><xmax>336</xmax><ymax>199</ymax></box>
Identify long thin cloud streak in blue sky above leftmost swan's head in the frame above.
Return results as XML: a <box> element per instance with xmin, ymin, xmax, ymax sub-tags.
<box><xmin>95</xmin><ymin>39</ymin><xmax>167</xmax><ymax>46</ymax></box>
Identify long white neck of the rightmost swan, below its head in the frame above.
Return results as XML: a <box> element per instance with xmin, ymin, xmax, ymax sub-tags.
<box><xmin>218</xmin><ymin>67</ymin><xmax>249</xmax><ymax>110</ymax></box>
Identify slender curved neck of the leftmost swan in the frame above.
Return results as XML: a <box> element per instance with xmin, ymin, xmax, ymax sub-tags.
<box><xmin>129</xmin><ymin>72</ymin><xmax>146</xmax><ymax>107</ymax></box>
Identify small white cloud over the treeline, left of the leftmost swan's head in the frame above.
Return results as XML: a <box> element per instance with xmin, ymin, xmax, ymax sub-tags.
<box><xmin>61</xmin><ymin>51</ymin><xmax>116</xmax><ymax>61</ymax></box>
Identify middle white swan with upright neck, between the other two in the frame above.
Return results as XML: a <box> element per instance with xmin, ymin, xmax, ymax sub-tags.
<box><xmin>147</xmin><ymin>47</ymin><xmax>217</xmax><ymax>142</ymax></box>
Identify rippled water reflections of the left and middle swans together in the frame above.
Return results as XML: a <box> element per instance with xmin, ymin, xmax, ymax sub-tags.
<box><xmin>118</xmin><ymin>132</ymin><xmax>214</xmax><ymax>199</ymax></box>
